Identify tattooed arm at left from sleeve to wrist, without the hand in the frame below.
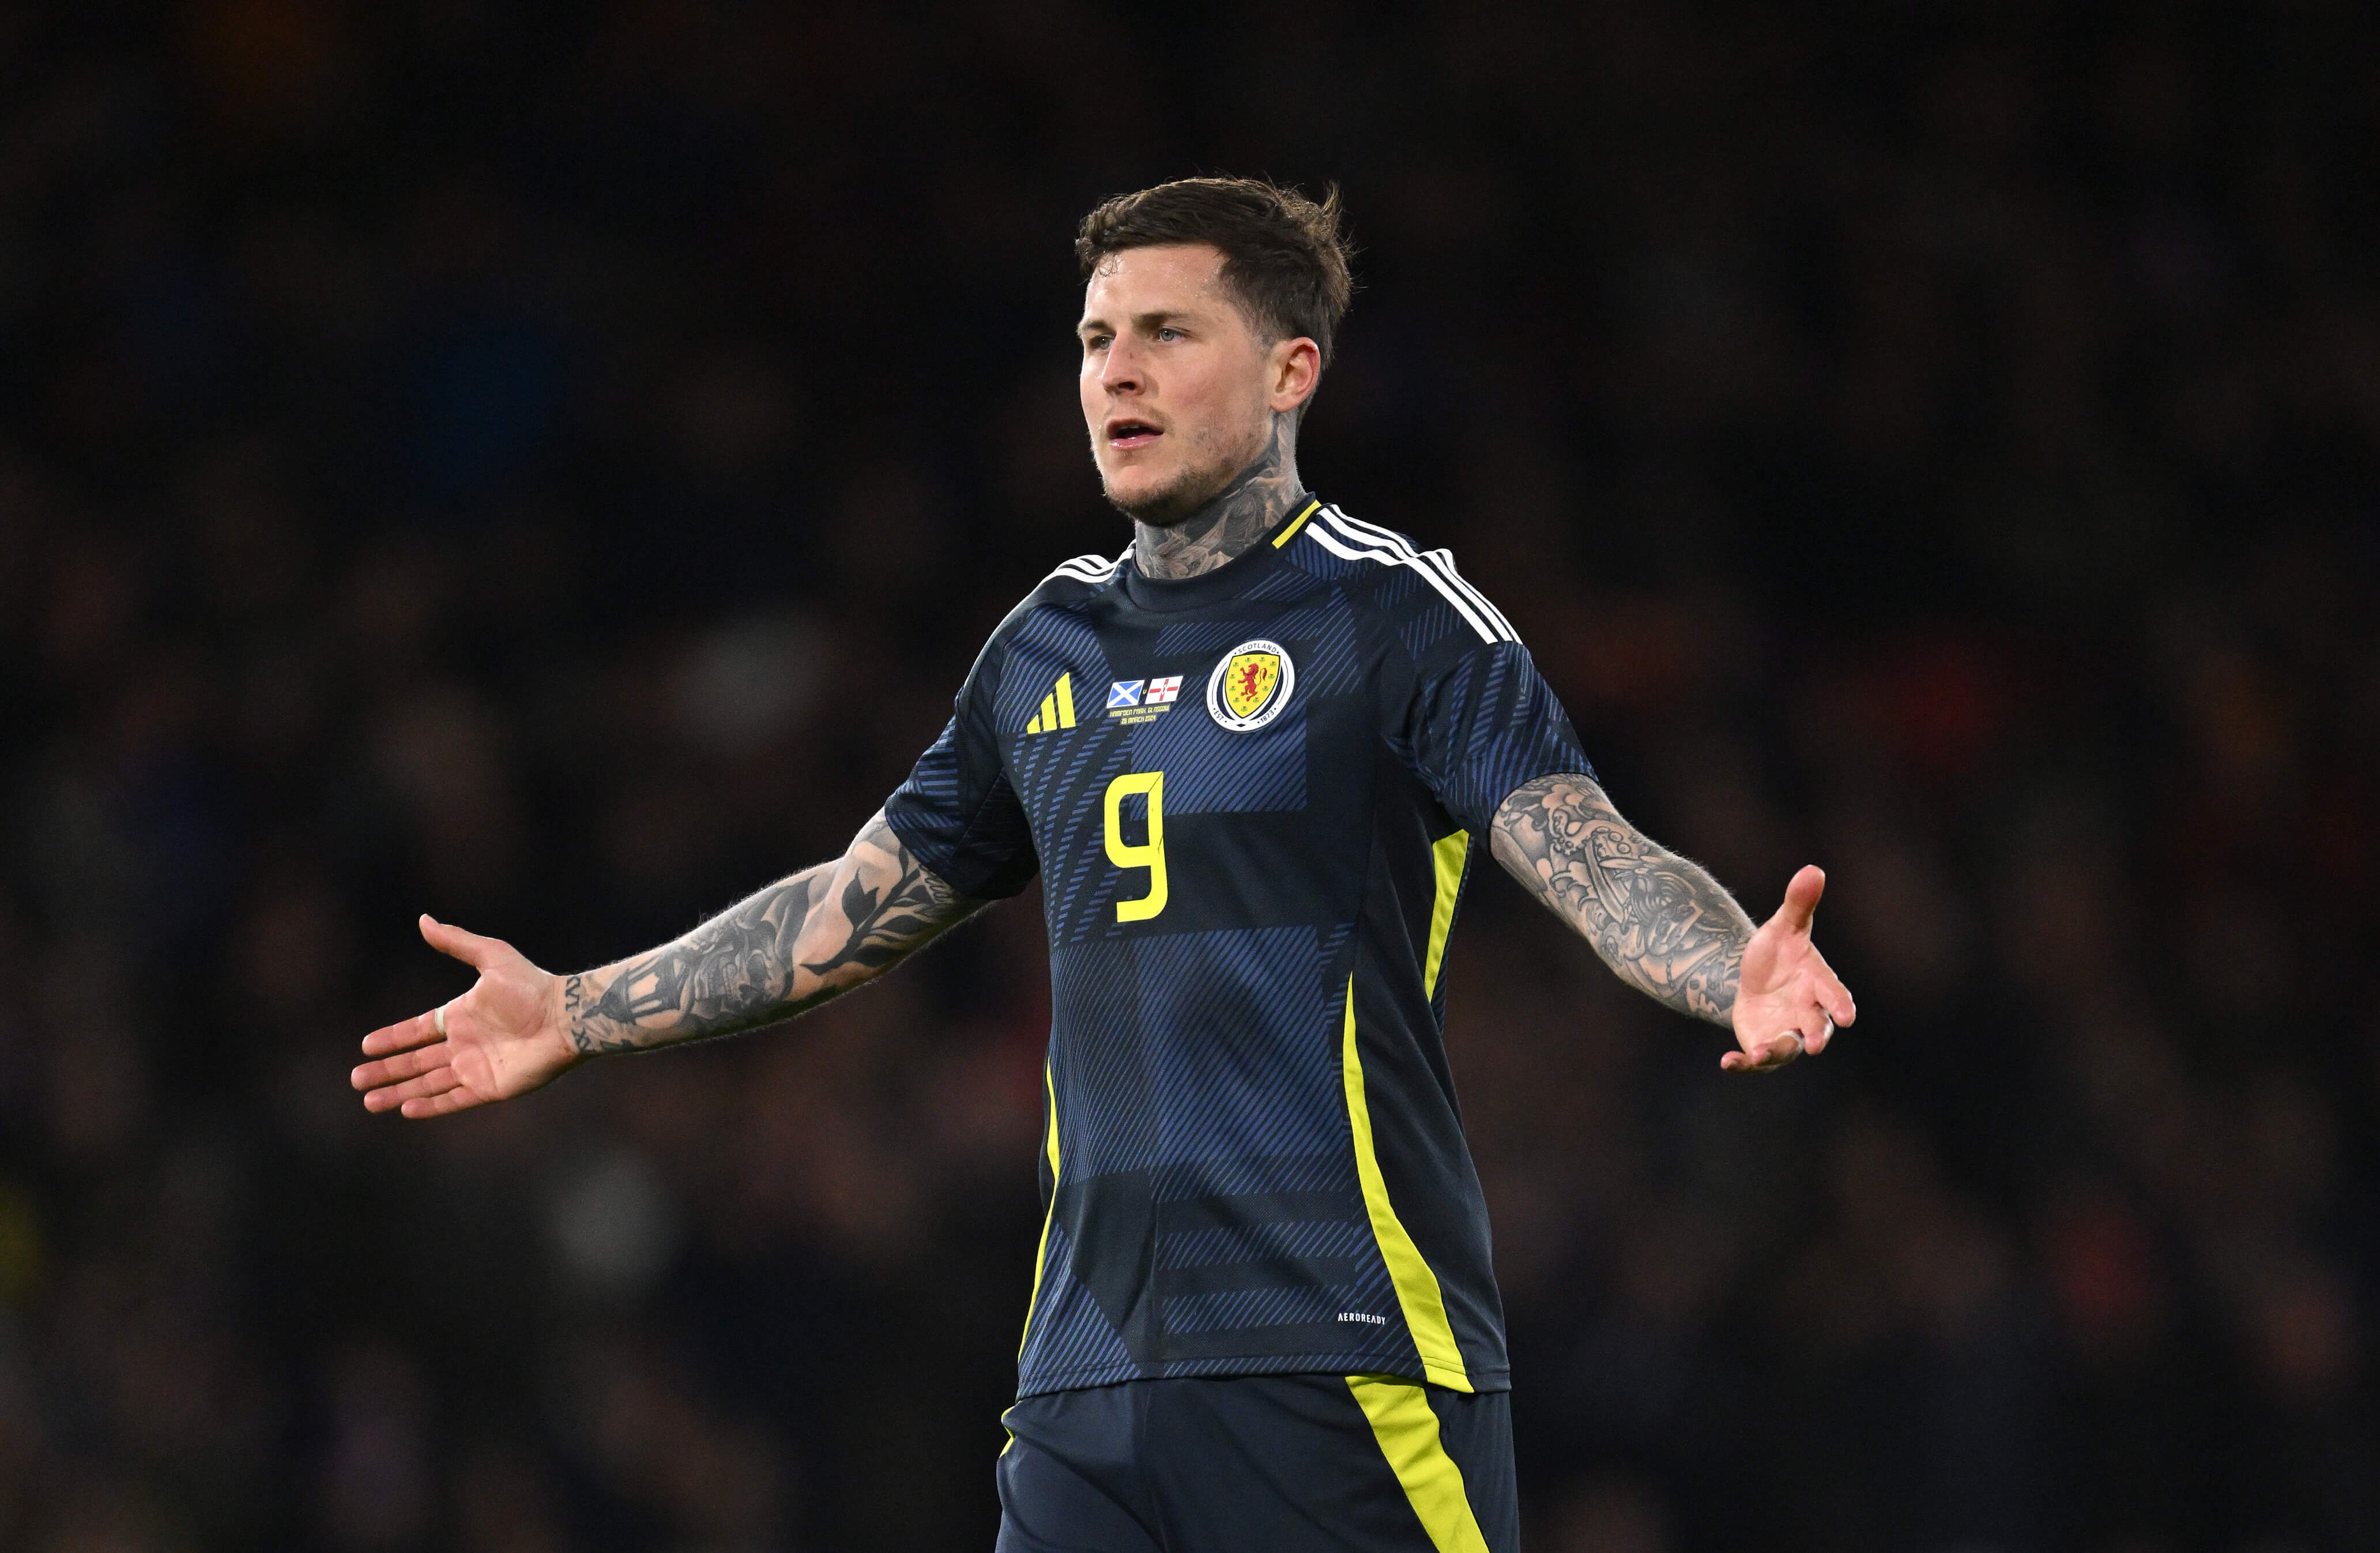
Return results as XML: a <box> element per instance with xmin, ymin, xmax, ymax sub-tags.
<box><xmin>562</xmin><ymin>813</ymin><xmax>985</xmax><ymax>1056</ymax></box>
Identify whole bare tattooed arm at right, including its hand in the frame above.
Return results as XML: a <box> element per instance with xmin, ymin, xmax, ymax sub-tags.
<box><xmin>1490</xmin><ymin>775</ymin><xmax>1856</xmax><ymax>1073</ymax></box>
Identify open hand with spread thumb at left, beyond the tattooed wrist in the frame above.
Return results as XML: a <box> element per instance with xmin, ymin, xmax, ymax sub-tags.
<box><xmin>350</xmin><ymin>915</ymin><xmax>581</xmax><ymax>1118</ymax></box>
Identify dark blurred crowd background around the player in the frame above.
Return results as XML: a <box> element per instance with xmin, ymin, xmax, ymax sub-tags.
<box><xmin>0</xmin><ymin>0</ymin><xmax>2380</xmax><ymax>1553</ymax></box>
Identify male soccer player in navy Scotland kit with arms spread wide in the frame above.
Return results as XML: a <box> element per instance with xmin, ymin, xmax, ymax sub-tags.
<box><xmin>355</xmin><ymin>178</ymin><xmax>1852</xmax><ymax>1553</ymax></box>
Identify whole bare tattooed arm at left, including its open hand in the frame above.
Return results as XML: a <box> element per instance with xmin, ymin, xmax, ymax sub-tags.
<box><xmin>352</xmin><ymin>813</ymin><xmax>988</xmax><ymax>1118</ymax></box>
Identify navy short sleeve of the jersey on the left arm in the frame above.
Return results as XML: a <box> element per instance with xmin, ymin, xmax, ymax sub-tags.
<box><xmin>886</xmin><ymin>638</ymin><xmax>1040</xmax><ymax>902</ymax></box>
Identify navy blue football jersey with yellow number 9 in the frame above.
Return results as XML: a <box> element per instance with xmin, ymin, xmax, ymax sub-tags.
<box><xmin>886</xmin><ymin>502</ymin><xmax>1590</xmax><ymax>1396</ymax></box>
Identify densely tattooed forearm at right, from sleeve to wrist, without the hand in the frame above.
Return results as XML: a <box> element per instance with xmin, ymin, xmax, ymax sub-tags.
<box><xmin>1492</xmin><ymin>775</ymin><xmax>1752</xmax><ymax>1025</ymax></box>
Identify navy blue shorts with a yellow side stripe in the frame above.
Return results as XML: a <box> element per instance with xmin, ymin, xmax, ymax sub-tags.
<box><xmin>997</xmin><ymin>1375</ymin><xmax>1521</xmax><ymax>1553</ymax></box>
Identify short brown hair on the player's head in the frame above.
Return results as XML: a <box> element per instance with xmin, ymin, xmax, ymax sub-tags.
<box><xmin>1074</xmin><ymin>178</ymin><xmax>1354</xmax><ymax>366</ymax></box>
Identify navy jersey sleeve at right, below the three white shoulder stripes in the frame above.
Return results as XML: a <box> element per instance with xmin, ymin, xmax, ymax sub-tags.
<box><xmin>1404</xmin><ymin>640</ymin><xmax>1595</xmax><ymax>835</ymax></box>
